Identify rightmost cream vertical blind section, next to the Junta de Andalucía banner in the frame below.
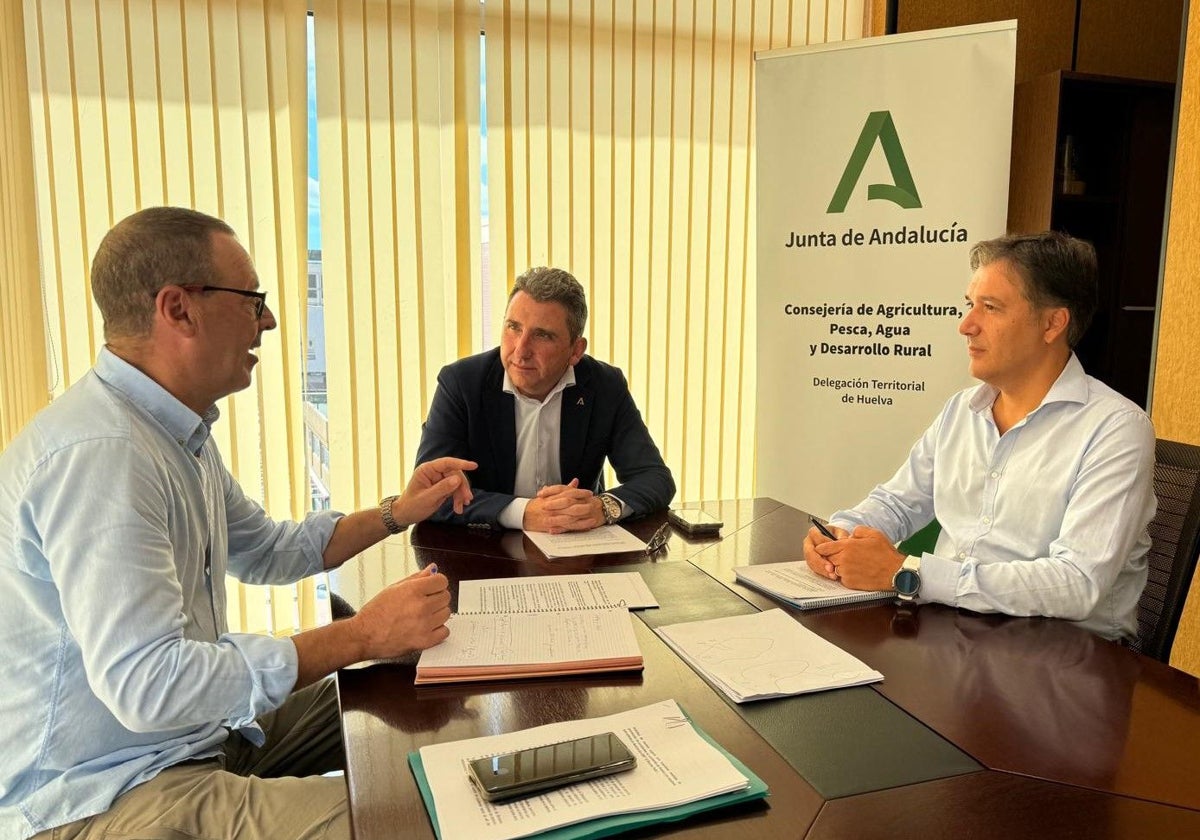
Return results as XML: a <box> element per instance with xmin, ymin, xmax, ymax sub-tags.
<box><xmin>485</xmin><ymin>0</ymin><xmax>864</xmax><ymax>500</ymax></box>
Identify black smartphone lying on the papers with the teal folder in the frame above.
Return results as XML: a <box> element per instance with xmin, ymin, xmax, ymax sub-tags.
<box><xmin>470</xmin><ymin>732</ymin><xmax>637</xmax><ymax>802</ymax></box>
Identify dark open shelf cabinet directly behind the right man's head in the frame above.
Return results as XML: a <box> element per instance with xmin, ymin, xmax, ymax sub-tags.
<box><xmin>1008</xmin><ymin>72</ymin><xmax>1175</xmax><ymax>406</ymax></box>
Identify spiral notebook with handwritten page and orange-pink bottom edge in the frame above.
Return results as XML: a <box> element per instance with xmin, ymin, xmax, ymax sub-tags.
<box><xmin>416</xmin><ymin>607</ymin><xmax>642</xmax><ymax>685</ymax></box>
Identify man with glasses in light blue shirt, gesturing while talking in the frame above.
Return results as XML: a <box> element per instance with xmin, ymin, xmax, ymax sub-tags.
<box><xmin>0</xmin><ymin>208</ymin><xmax>474</xmax><ymax>840</ymax></box>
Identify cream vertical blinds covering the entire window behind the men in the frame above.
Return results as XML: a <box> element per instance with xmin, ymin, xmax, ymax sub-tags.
<box><xmin>0</xmin><ymin>0</ymin><xmax>870</xmax><ymax>632</ymax></box>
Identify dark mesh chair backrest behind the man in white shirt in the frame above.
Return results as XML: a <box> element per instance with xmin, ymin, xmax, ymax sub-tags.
<box><xmin>1132</xmin><ymin>439</ymin><xmax>1200</xmax><ymax>662</ymax></box>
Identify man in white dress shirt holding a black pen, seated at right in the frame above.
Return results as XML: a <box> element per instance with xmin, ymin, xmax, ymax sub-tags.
<box><xmin>804</xmin><ymin>232</ymin><xmax>1156</xmax><ymax>640</ymax></box>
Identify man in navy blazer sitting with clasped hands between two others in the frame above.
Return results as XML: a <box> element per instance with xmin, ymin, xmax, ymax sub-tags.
<box><xmin>416</xmin><ymin>268</ymin><xmax>676</xmax><ymax>533</ymax></box>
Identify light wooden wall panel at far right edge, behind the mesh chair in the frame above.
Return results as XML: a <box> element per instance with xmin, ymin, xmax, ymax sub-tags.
<box><xmin>1151</xmin><ymin>3</ymin><xmax>1200</xmax><ymax>674</ymax></box>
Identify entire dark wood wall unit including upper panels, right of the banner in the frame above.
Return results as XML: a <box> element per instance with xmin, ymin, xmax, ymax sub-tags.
<box><xmin>890</xmin><ymin>0</ymin><xmax>1183</xmax><ymax>406</ymax></box>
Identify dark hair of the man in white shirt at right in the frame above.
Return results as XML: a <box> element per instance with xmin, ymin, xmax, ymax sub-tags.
<box><xmin>971</xmin><ymin>230</ymin><xmax>1098</xmax><ymax>347</ymax></box>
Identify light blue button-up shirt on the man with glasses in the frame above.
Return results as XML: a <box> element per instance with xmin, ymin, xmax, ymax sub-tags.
<box><xmin>0</xmin><ymin>349</ymin><xmax>340</xmax><ymax>839</ymax></box>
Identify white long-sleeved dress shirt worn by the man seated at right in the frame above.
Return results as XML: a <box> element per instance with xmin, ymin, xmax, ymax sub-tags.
<box><xmin>829</xmin><ymin>355</ymin><xmax>1156</xmax><ymax>640</ymax></box>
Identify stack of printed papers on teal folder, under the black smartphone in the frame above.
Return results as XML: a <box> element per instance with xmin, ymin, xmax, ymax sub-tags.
<box><xmin>409</xmin><ymin>700</ymin><xmax>767</xmax><ymax>840</ymax></box>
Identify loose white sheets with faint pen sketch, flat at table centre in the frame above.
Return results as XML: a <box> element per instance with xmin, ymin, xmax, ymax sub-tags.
<box><xmin>659</xmin><ymin>610</ymin><xmax>883</xmax><ymax>703</ymax></box>
